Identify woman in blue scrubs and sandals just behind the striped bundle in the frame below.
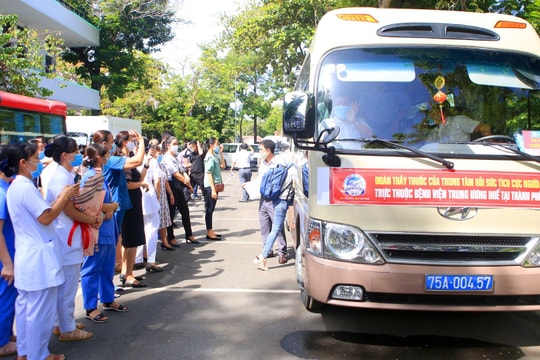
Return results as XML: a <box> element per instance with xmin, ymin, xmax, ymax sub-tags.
<box><xmin>81</xmin><ymin>143</ymin><xmax>124</xmax><ymax>324</ymax></box>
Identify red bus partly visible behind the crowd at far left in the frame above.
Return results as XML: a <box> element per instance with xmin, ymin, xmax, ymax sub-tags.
<box><xmin>0</xmin><ymin>91</ymin><xmax>67</xmax><ymax>144</ymax></box>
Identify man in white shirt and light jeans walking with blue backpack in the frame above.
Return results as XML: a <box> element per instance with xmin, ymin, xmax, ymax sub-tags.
<box><xmin>253</xmin><ymin>139</ymin><xmax>294</xmax><ymax>271</ymax></box>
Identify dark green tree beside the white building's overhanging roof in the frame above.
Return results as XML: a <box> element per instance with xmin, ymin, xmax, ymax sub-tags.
<box><xmin>64</xmin><ymin>0</ymin><xmax>175</xmax><ymax>108</ymax></box>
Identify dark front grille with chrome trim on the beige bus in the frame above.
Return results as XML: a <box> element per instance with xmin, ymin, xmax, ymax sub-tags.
<box><xmin>369</xmin><ymin>234</ymin><xmax>538</xmax><ymax>265</ymax></box>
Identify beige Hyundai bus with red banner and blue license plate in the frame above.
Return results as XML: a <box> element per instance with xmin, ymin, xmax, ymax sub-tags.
<box><xmin>283</xmin><ymin>8</ymin><xmax>540</xmax><ymax>311</ymax></box>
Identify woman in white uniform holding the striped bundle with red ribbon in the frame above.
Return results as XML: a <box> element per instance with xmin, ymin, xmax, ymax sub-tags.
<box><xmin>43</xmin><ymin>136</ymin><xmax>97</xmax><ymax>341</ymax></box>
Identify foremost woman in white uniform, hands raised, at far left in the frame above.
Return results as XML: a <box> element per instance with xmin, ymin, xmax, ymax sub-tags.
<box><xmin>3</xmin><ymin>143</ymin><xmax>80</xmax><ymax>360</ymax></box>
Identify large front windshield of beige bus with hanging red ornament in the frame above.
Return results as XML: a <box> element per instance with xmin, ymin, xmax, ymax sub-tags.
<box><xmin>315</xmin><ymin>47</ymin><xmax>540</xmax><ymax>153</ymax></box>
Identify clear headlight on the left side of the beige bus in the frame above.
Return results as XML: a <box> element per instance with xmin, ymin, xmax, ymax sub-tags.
<box><xmin>323</xmin><ymin>223</ymin><xmax>384</xmax><ymax>264</ymax></box>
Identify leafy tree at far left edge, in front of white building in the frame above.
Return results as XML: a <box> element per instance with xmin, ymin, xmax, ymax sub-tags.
<box><xmin>0</xmin><ymin>14</ymin><xmax>62</xmax><ymax>97</ymax></box>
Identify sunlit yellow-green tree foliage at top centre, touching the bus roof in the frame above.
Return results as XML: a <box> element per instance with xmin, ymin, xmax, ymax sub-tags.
<box><xmin>221</xmin><ymin>0</ymin><xmax>336</xmax><ymax>90</ymax></box>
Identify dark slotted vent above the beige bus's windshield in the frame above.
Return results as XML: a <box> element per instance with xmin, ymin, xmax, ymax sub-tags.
<box><xmin>377</xmin><ymin>23</ymin><xmax>499</xmax><ymax>41</ymax></box>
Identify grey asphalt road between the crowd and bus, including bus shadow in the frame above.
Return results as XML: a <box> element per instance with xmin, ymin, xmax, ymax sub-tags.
<box><xmin>50</xmin><ymin>171</ymin><xmax>540</xmax><ymax>360</ymax></box>
